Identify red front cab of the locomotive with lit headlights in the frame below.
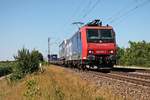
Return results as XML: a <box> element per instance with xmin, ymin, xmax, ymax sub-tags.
<box><xmin>81</xmin><ymin>19</ymin><xmax>116</xmax><ymax>68</ymax></box>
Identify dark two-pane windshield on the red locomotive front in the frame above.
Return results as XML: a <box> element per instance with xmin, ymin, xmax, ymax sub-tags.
<box><xmin>87</xmin><ymin>29</ymin><xmax>114</xmax><ymax>43</ymax></box>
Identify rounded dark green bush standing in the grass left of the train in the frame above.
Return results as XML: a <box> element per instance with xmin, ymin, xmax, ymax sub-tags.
<box><xmin>10</xmin><ymin>48</ymin><xmax>43</xmax><ymax>80</ymax></box>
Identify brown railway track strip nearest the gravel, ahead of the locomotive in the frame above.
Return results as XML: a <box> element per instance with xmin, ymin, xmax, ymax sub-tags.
<box><xmin>90</xmin><ymin>71</ymin><xmax>150</xmax><ymax>87</ymax></box>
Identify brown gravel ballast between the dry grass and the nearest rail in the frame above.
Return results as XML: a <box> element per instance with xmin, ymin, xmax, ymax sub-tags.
<box><xmin>64</xmin><ymin>69</ymin><xmax>150</xmax><ymax>100</ymax></box>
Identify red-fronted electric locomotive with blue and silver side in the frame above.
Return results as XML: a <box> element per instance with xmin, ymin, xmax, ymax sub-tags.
<box><xmin>54</xmin><ymin>20</ymin><xmax>116</xmax><ymax>69</ymax></box>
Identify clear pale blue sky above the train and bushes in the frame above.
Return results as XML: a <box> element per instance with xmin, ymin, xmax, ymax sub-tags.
<box><xmin>0</xmin><ymin>0</ymin><xmax>150</xmax><ymax>60</ymax></box>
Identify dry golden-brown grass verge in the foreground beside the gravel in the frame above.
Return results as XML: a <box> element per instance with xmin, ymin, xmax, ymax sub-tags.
<box><xmin>0</xmin><ymin>65</ymin><xmax>123</xmax><ymax>100</ymax></box>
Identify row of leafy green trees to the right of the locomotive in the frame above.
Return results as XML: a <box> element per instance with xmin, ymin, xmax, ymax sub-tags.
<box><xmin>117</xmin><ymin>40</ymin><xmax>150</xmax><ymax>67</ymax></box>
